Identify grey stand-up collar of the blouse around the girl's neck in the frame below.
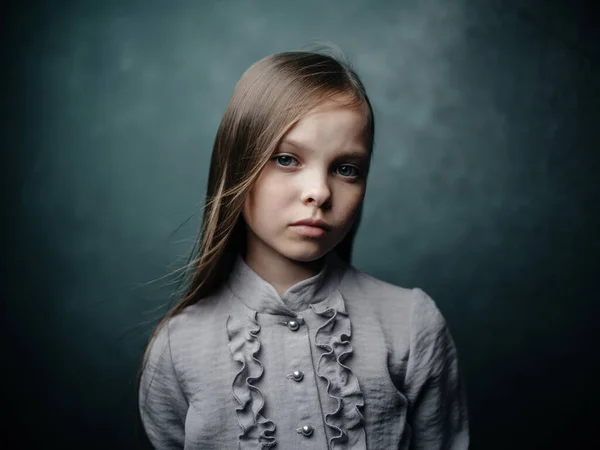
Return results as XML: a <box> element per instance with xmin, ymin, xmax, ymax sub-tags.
<box><xmin>227</xmin><ymin>250</ymin><xmax>347</xmax><ymax>316</ymax></box>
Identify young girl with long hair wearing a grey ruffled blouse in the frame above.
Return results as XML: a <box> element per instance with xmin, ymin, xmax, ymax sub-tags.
<box><xmin>139</xmin><ymin>47</ymin><xmax>469</xmax><ymax>450</ymax></box>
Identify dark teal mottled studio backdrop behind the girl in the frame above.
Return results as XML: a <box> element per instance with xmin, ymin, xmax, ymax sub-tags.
<box><xmin>0</xmin><ymin>0</ymin><xmax>600</xmax><ymax>449</ymax></box>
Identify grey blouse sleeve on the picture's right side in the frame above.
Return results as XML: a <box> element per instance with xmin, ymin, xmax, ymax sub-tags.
<box><xmin>405</xmin><ymin>288</ymin><xmax>469</xmax><ymax>450</ymax></box>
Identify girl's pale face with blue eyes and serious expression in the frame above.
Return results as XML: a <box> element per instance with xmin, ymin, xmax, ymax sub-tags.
<box><xmin>243</xmin><ymin>98</ymin><xmax>370</xmax><ymax>263</ymax></box>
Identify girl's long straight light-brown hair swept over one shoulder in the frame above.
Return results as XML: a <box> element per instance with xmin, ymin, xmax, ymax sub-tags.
<box><xmin>137</xmin><ymin>51</ymin><xmax>375</xmax><ymax>436</ymax></box>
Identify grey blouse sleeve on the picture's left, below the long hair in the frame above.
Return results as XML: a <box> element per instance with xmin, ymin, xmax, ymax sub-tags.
<box><xmin>139</xmin><ymin>323</ymin><xmax>188</xmax><ymax>450</ymax></box>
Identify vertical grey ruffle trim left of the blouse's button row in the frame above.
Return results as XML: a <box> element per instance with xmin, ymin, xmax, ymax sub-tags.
<box><xmin>227</xmin><ymin>311</ymin><xmax>277</xmax><ymax>450</ymax></box>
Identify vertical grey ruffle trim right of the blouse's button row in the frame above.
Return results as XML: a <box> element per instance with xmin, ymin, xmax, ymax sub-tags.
<box><xmin>311</xmin><ymin>291</ymin><xmax>366</xmax><ymax>449</ymax></box>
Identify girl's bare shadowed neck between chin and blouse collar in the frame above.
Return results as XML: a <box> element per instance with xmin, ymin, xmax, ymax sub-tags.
<box><xmin>244</xmin><ymin>244</ymin><xmax>325</xmax><ymax>297</ymax></box>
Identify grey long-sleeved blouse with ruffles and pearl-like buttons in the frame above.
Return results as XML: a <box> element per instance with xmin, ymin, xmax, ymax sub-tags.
<box><xmin>139</xmin><ymin>251</ymin><xmax>469</xmax><ymax>450</ymax></box>
